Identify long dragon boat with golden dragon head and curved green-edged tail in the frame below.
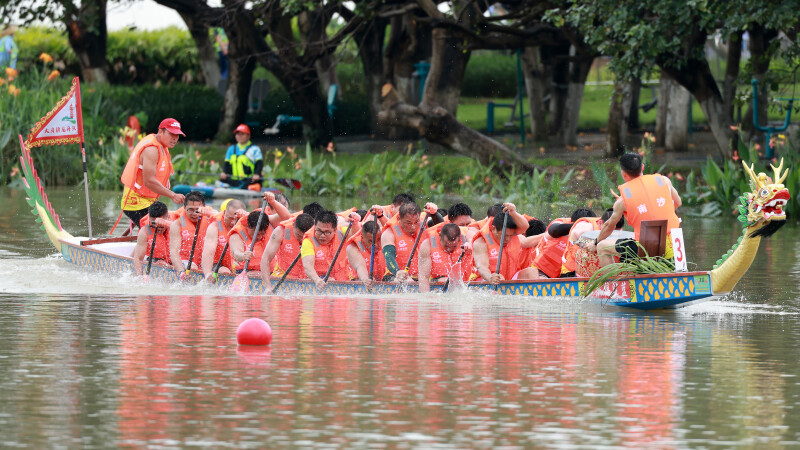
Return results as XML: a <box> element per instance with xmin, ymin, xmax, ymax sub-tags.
<box><xmin>20</xmin><ymin>147</ymin><xmax>790</xmax><ymax>310</ymax></box>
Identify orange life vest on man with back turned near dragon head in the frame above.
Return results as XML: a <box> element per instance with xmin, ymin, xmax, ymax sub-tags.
<box><xmin>619</xmin><ymin>174</ymin><xmax>681</xmax><ymax>241</ymax></box>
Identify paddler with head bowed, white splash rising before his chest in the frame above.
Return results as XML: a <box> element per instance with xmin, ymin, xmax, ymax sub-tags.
<box><xmin>419</xmin><ymin>223</ymin><xmax>472</xmax><ymax>292</ymax></box>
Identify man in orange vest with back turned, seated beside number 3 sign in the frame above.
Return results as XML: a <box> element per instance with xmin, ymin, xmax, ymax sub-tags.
<box><xmin>587</xmin><ymin>153</ymin><xmax>681</xmax><ymax>267</ymax></box>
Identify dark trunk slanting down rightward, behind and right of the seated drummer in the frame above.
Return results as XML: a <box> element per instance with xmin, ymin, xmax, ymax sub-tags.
<box><xmin>659</xmin><ymin>59</ymin><xmax>733</xmax><ymax>158</ymax></box>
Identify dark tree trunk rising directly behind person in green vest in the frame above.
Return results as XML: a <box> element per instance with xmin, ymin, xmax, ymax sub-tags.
<box><xmin>215</xmin><ymin>52</ymin><xmax>256</xmax><ymax>141</ymax></box>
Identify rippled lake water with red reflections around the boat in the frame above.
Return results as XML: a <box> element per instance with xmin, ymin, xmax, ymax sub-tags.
<box><xmin>0</xmin><ymin>189</ymin><xmax>800</xmax><ymax>448</ymax></box>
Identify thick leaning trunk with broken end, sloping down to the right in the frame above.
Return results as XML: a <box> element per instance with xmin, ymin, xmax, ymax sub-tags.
<box><xmin>378</xmin><ymin>84</ymin><xmax>535</xmax><ymax>171</ymax></box>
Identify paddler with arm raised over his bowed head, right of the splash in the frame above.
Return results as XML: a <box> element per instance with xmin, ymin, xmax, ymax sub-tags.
<box><xmin>472</xmin><ymin>203</ymin><xmax>528</xmax><ymax>284</ymax></box>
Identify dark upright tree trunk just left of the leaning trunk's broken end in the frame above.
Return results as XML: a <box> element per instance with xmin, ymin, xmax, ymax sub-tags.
<box><xmin>356</xmin><ymin>18</ymin><xmax>389</xmax><ymax>137</ymax></box>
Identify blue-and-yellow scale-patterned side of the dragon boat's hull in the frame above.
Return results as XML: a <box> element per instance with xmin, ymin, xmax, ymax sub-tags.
<box><xmin>61</xmin><ymin>241</ymin><xmax>713</xmax><ymax>310</ymax></box>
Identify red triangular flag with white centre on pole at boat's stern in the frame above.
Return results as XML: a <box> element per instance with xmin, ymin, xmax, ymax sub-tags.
<box><xmin>25</xmin><ymin>77</ymin><xmax>83</xmax><ymax>148</ymax></box>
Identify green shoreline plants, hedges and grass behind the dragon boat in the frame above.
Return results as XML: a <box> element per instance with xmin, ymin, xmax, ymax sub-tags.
<box><xmin>0</xmin><ymin>28</ymin><xmax>800</xmax><ymax>221</ymax></box>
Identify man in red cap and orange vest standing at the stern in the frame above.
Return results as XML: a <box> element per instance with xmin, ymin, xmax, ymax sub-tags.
<box><xmin>120</xmin><ymin>119</ymin><xmax>185</xmax><ymax>226</ymax></box>
